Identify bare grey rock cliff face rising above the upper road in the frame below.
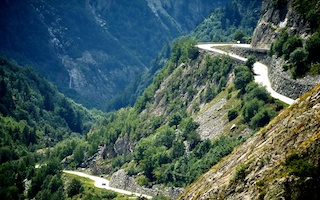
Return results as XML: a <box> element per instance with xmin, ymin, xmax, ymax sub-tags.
<box><xmin>251</xmin><ymin>0</ymin><xmax>311</xmax><ymax>48</ymax></box>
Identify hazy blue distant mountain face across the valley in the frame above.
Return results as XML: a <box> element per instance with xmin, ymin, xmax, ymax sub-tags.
<box><xmin>0</xmin><ymin>0</ymin><xmax>226</xmax><ymax>107</ymax></box>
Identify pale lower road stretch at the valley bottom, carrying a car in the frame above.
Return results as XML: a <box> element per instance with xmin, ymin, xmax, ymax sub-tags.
<box><xmin>63</xmin><ymin>170</ymin><xmax>152</xmax><ymax>199</ymax></box>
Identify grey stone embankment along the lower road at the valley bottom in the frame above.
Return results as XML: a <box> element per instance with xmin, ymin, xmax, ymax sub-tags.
<box><xmin>109</xmin><ymin>169</ymin><xmax>184</xmax><ymax>199</ymax></box>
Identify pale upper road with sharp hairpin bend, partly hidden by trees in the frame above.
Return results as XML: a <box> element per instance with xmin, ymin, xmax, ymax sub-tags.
<box><xmin>197</xmin><ymin>43</ymin><xmax>295</xmax><ymax>105</ymax></box>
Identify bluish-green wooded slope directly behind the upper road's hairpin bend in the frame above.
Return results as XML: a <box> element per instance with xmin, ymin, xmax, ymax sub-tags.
<box><xmin>190</xmin><ymin>0</ymin><xmax>262</xmax><ymax>43</ymax></box>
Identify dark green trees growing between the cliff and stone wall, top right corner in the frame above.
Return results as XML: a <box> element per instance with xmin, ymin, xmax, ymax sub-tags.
<box><xmin>269</xmin><ymin>0</ymin><xmax>320</xmax><ymax>78</ymax></box>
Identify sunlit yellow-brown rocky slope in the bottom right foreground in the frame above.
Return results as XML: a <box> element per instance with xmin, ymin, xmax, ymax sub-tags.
<box><xmin>180</xmin><ymin>82</ymin><xmax>320</xmax><ymax>199</ymax></box>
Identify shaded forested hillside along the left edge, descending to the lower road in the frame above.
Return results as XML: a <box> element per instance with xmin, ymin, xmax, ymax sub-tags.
<box><xmin>0</xmin><ymin>57</ymin><xmax>100</xmax><ymax>199</ymax></box>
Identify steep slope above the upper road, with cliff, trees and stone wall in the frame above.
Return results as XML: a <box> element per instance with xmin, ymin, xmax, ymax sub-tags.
<box><xmin>251</xmin><ymin>0</ymin><xmax>320</xmax><ymax>102</ymax></box>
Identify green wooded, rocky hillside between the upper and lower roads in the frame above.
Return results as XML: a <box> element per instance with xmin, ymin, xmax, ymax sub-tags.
<box><xmin>68</xmin><ymin>38</ymin><xmax>284</xmax><ymax>198</ymax></box>
